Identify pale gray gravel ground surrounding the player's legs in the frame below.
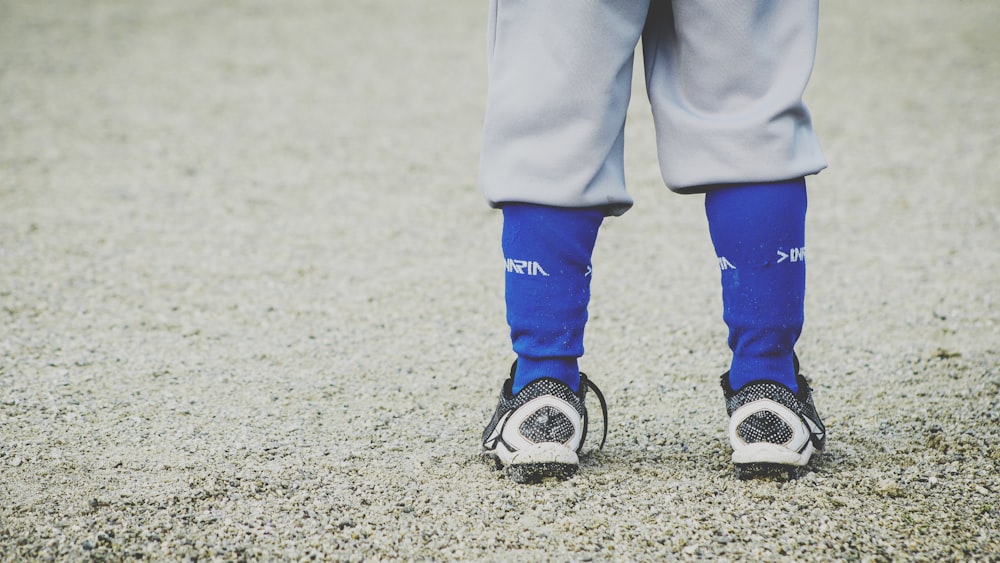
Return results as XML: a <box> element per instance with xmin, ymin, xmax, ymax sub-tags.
<box><xmin>0</xmin><ymin>0</ymin><xmax>1000</xmax><ymax>561</ymax></box>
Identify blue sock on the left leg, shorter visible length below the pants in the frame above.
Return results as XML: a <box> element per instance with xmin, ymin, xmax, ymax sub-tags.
<box><xmin>502</xmin><ymin>204</ymin><xmax>604</xmax><ymax>393</ymax></box>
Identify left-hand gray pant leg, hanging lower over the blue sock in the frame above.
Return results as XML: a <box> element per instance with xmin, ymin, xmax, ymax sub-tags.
<box><xmin>480</xmin><ymin>0</ymin><xmax>649</xmax><ymax>214</ymax></box>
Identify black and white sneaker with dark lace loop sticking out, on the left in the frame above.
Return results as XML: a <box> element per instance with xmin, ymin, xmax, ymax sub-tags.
<box><xmin>483</xmin><ymin>362</ymin><xmax>608</xmax><ymax>483</ymax></box>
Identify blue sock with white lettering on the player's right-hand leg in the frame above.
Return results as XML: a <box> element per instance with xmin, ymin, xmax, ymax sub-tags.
<box><xmin>705</xmin><ymin>178</ymin><xmax>806</xmax><ymax>391</ymax></box>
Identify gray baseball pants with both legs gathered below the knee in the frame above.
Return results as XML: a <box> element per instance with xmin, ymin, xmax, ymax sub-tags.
<box><xmin>480</xmin><ymin>0</ymin><xmax>826</xmax><ymax>215</ymax></box>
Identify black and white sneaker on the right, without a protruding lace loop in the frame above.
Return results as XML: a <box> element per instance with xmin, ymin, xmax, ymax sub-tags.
<box><xmin>722</xmin><ymin>359</ymin><xmax>826</xmax><ymax>479</ymax></box>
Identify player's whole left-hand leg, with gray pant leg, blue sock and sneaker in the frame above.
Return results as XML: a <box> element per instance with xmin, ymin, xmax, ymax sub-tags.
<box><xmin>480</xmin><ymin>0</ymin><xmax>648</xmax><ymax>481</ymax></box>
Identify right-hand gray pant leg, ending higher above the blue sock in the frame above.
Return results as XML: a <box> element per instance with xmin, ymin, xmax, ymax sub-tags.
<box><xmin>642</xmin><ymin>0</ymin><xmax>826</xmax><ymax>192</ymax></box>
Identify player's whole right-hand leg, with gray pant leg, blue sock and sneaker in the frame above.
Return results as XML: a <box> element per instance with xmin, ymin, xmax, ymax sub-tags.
<box><xmin>643</xmin><ymin>0</ymin><xmax>826</xmax><ymax>478</ymax></box>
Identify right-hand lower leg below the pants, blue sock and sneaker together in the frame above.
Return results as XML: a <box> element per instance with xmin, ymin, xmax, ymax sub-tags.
<box><xmin>705</xmin><ymin>178</ymin><xmax>826</xmax><ymax>477</ymax></box>
